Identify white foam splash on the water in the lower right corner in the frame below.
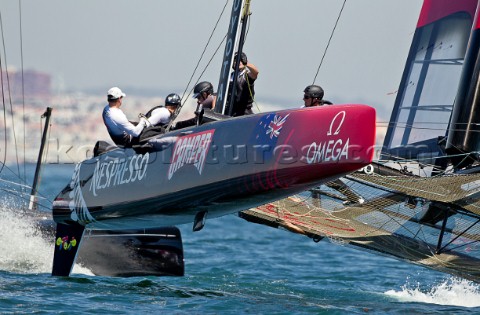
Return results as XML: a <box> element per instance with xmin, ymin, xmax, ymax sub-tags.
<box><xmin>385</xmin><ymin>278</ymin><xmax>480</xmax><ymax>307</ymax></box>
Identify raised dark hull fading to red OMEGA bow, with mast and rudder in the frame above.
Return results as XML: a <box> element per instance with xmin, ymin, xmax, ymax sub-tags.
<box><xmin>52</xmin><ymin>0</ymin><xmax>376</xmax><ymax>276</ymax></box>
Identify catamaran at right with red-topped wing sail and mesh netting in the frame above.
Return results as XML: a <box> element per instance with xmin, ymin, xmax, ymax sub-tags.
<box><xmin>240</xmin><ymin>0</ymin><xmax>480</xmax><ymax>282</ymax></box>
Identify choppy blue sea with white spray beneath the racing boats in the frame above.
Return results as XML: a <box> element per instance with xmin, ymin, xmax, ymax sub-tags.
<box><xmin>0</xmin><ymin>165</ymin><xmax>480</xmax><ymax>314</ymax></box>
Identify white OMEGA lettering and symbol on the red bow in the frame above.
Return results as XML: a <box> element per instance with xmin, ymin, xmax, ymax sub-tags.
<box><xmin>307</xmin><ymin>111</ymin><xmax>350</xmax><ymax>164</ymax></box>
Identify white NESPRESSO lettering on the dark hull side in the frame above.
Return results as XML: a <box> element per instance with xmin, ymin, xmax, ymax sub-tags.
<box><xmin>90</xmin><ymin>153</ymin><xmax>150</xmax><ymax>196</ymax></box>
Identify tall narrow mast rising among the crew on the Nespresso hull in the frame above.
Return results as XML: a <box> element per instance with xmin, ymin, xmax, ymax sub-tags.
<box><xmin>214</xmin><ymin>0</ymin><xmax>250</xmax><ymax>114</ymax></box>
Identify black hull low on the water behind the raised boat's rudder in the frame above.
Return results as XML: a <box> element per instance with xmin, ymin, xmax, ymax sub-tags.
<box><xmin>37</xmin><ymin>219</ymin><xmax>185</xmax><ymax>277</ymax></box>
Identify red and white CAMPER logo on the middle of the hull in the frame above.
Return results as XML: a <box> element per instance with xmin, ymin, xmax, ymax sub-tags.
<box><xmin>168</xmin><ymin>129</ymin><xmax>215</xmax><ymax>179</ymax></box>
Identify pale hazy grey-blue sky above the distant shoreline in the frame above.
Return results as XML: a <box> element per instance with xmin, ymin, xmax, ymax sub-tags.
<box><xmin>0</xmin><ymin>0</ymin><xmax>422</xmax><ymax>120</ymax></box>
